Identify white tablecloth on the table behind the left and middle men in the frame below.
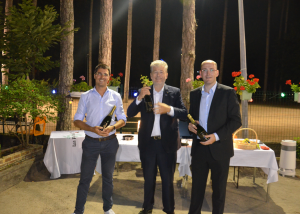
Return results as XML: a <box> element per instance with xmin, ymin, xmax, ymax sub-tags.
<box><xmin>44</xmin><ymin>130</ymin><xmax>191</xmax><ymax>179</ymax></box>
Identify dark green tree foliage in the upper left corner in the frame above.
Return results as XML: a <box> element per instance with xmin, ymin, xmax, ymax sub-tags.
<box><xmin>0</xmin><ymin>0</ymin><xmax>75</xmax><ymax>79</ymax></box>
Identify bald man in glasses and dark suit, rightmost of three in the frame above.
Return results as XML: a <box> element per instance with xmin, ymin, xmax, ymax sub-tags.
<box><xmin>188</xmin><ymin>60</ymin><xmax>242</xmax><ymax>214</ymax></box>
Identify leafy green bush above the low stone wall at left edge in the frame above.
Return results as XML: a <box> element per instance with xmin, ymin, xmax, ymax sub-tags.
<box><xmin>0</xmin><ymin>77</ymin><xmax>64</xmax><ymax>146</ymax></box>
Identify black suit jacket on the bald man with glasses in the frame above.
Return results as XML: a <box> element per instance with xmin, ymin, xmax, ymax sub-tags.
<box><xmin>190</xmin><ymin>83</ymin><xmax>242</xmax><ymax>160</ymax></box>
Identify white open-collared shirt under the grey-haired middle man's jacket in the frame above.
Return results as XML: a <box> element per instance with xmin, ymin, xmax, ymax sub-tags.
<box><xmin>136</xmin><ymin>87</ymin><xmax>174</xmax><ymax>137</ymax></box>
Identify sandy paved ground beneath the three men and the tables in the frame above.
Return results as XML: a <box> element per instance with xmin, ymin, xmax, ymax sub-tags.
<box><xmin>0</xmin><ymin>160</ymin><xmax>300</xmax><ymax>214</ymax></box>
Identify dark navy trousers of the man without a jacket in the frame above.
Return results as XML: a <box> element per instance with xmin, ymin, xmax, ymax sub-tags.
<box><xmin>74</xmin><ymin>138</ymin><xmax>119</xmax><ymax>214</ymax></box>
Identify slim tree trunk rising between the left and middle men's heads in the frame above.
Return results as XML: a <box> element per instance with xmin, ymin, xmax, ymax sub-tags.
<box><xmin>123</xmin><ymin>0</ymin><xmax>132</xmax><ymax>103</ymax></box>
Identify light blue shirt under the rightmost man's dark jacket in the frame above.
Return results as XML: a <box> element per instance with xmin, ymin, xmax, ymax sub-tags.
<box><xmin>198</xmin><ymin>82</ymin><xmax>220</xmax><ymax>141</ymax></box>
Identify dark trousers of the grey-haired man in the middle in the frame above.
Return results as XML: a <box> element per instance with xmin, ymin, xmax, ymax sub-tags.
<box><xmin>140</xmin><ymin>139</ymin><xmax>177</xmax><ymax>213</ymax></box>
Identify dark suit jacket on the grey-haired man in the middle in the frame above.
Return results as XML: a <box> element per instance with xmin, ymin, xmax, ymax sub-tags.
<box><xmin>127</xmin><ymin>85</ymin><xmax>187</xmax><ymax>153</ymax></box>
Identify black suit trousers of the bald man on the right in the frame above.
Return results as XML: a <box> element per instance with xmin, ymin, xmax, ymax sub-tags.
<box><xmin>189</xmin><ymin>146</ymin><xmax>230</xmax><ymax>214</ymax></box>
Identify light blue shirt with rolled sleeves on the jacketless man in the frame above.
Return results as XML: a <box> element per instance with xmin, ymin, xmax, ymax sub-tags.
<box><xmin>74</xmin><ymin>88</ymin><xmax>126</xmax><ymax>138</ymax></box>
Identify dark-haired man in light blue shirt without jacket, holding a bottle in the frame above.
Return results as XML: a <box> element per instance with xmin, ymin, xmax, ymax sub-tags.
<box><xmin>74</xmin><ymin>64</ymin><xmax>126</xmax><ymax>214</ymax></box>
